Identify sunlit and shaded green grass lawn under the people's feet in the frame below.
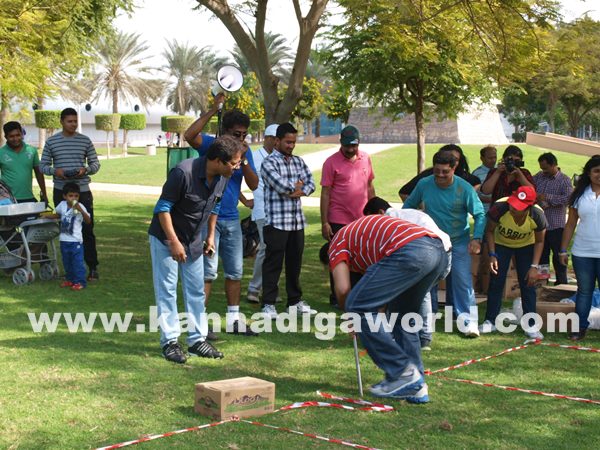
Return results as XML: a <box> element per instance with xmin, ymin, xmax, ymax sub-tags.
<box><xmin>0</xmin><ymin>192</ymin><xmax>600</xmax><ymax>449</ymax></box>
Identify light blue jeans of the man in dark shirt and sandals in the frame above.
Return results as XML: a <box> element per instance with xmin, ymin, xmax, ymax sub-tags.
<box><xmin>150</xmin><ymin>236</ymin><xmax>208</xmax><ymax>347</ymax></box>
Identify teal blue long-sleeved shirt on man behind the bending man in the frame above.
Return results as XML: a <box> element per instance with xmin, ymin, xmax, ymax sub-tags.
<box><xmin>403</xmin><ymin>175</ymin><xmax>485</xmax><ymax>244</ymax></box>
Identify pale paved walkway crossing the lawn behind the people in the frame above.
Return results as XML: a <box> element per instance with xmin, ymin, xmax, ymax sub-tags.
<box><xmin>46</xmin><ymin>144</ymin><xmax>399</xmax><ymax>207</ymax></box>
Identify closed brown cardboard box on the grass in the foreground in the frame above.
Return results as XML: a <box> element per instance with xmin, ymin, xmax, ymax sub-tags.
<box><xmin>194</xmin><ymin>377</ymin><xmax>275</xmax><ymax>420</ymax></box>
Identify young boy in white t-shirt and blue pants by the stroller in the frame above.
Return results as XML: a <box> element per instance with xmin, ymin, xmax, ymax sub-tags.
<box><xmin>51</xmin><ymin>183</ymin><xmax>92</xmax><ymax>291</ymax></box>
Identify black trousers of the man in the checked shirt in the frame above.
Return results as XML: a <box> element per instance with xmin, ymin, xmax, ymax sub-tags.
<box><xmin>263</xmin><ymin>225</ymin><xmax>304</xmax><ymax>306</ymax></box>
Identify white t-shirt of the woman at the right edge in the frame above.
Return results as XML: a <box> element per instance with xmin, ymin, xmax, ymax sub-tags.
<box><xmin>571</xmin><ymin>186</ymin><xmax>600</xmax><ymax>258</ymax></box>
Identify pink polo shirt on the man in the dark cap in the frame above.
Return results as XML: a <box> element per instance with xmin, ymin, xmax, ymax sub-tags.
<box><xmin>321</xmin><ymin>150</ymin><xmax>375</xmax><ymax>225</ymax></box>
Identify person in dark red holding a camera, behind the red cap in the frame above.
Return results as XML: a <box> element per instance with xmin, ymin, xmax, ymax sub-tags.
<box><xmin>481</xmin><ymin>145</ymin><xmax>535</xmax><ymax>203</ymax></box>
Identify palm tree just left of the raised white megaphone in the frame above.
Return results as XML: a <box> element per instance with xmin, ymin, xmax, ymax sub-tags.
<box><xmin>161</xmin><ymin>41</ymin><xmax>225</xmax><ymax>115</ymax></box>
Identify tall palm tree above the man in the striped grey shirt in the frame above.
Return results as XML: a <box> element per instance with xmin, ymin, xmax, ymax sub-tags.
<box><xmin>92</xmin><ymin>31</ymin><xmax>164</xmax><ymax>146</ymax></box>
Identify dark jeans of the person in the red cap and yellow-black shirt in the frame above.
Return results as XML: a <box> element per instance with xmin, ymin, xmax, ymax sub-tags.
<box><xmin>485</xmin><ymin>244</ymin><xmax>536</xmax><ymax>325</ymax></box>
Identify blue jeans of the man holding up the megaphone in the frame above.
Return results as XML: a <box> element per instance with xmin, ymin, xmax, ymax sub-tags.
<box><xmin>204</xmin><ymin>220</ymin><xmax>244</xmax><ymax>281</ymax></box>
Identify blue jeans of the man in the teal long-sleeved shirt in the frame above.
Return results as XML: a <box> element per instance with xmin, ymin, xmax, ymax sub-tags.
<box><xmin>446</xmin><ymin>242</ymin><xmax>478</xmax><ymax>324</ymax></box>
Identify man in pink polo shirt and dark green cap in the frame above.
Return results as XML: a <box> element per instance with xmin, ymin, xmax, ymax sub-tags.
<box><xmin>321</xmin><ymin>125</ymin><xmax>375</xmax><ymax>307</ymax></box>
